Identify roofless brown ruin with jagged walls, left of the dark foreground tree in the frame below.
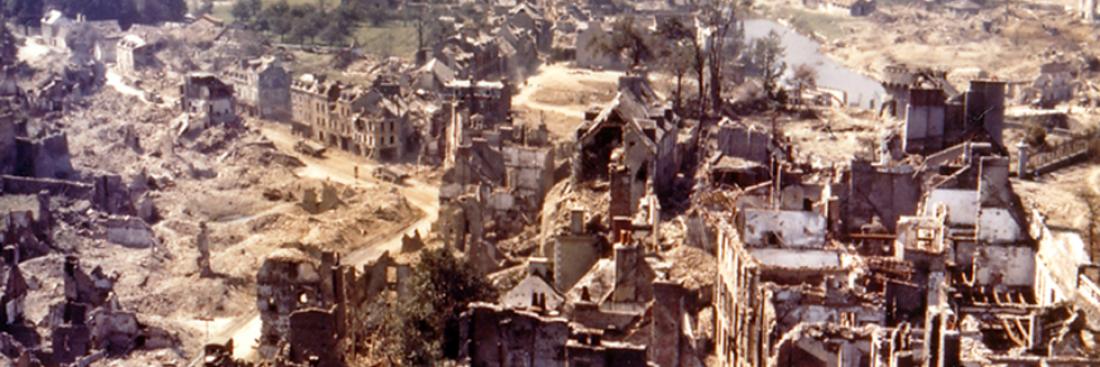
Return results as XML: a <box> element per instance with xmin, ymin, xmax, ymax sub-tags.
<box><xmin>257</xmin><ymin>248</ymin><xmax>411</xmax><ymax>367</ymax></box>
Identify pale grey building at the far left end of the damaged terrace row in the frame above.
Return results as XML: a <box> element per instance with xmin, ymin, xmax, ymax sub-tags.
<box><xmin>223</xmin><ymin>57</ymin><xmax>292</xmax><ymax>121</ymax></box>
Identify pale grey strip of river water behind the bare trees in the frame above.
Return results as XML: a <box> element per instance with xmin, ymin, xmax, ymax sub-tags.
<box><xmin>745</xmin><ymin>19</ymin><xmax>887</xmax><ymax>108</ymax></box>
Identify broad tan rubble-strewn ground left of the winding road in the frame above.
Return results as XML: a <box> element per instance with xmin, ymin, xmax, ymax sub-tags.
<box><xmin>26</xmin><ymin>75</ymin><xmax>429</xmax><ymax>366</ymax></box>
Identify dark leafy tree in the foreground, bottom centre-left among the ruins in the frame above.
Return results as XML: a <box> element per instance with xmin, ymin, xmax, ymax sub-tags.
<box><xmin>367</xmin><ymin>248</ymin><xmax>497</xmax><ymax>366</ymax></box>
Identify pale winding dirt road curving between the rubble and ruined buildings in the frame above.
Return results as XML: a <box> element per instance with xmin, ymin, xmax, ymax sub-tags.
<box><xmin>210</xmin><ymin>125</ymin><xmax>439</xmax><ymax>359</ymax></box>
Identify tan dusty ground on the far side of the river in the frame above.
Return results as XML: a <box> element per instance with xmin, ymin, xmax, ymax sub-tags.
<box><xmin>755</xmin><ymin>0</ymin><xmax>1097</xmax><ymax>84</ymax></box>
